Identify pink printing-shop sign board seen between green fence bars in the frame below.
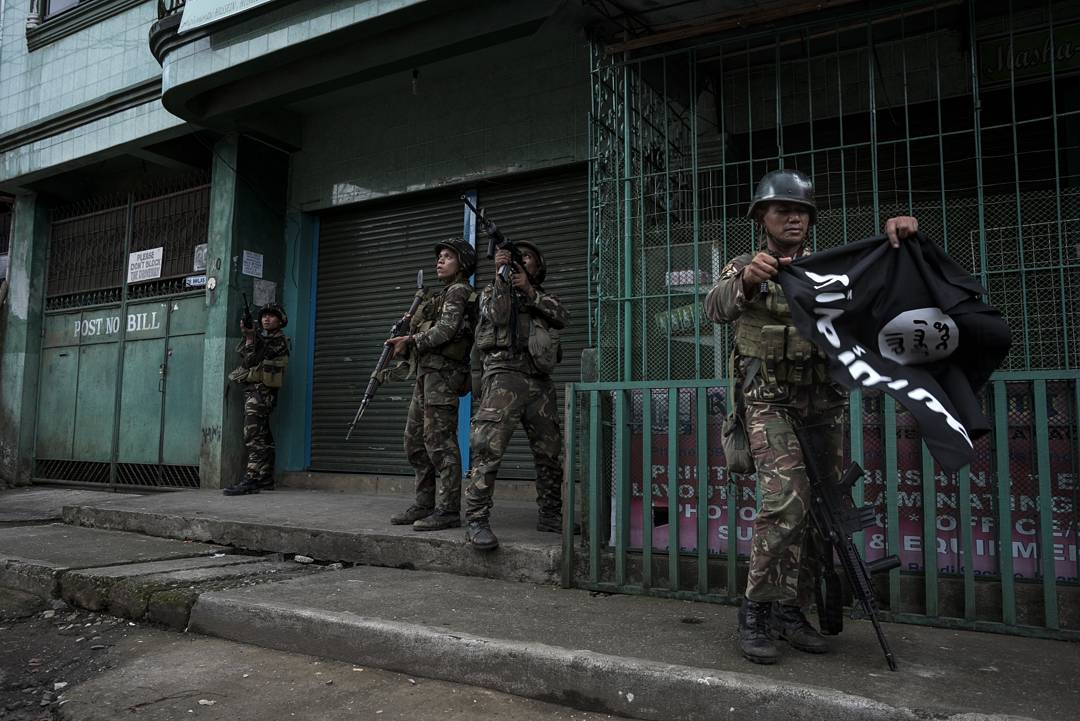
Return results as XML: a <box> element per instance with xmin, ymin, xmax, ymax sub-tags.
<box><xmin>630</xmin><ymin>383</ymin><xmax>1080</xmax><ymax>582</ymax></box>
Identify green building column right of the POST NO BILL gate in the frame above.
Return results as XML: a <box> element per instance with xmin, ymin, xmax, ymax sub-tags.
<box><xmin>199</xmin><ymin>134</ymin><xmax>292</xmax><ymax>488</ymax></box>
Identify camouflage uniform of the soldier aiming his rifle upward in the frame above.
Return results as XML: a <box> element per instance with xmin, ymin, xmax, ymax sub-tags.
<box><xmin>465</xmin><ymin>274</ymin><xmax>567</xmax><ymax>523</ymax></box>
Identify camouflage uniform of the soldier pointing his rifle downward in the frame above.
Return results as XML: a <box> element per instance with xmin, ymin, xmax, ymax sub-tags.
<box><xmin>405</xmin><ymin>281</ymin><xmax>476</xmax><ymax>515</ymax></box>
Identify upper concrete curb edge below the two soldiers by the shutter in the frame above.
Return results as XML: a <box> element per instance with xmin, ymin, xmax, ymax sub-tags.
<box><xmin>64</xmin><ymin>506</ymin><xmax>563</xmax><ymax>584</ymax></box>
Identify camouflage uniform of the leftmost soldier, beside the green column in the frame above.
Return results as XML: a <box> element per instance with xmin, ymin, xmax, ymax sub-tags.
<box><xmin>237</xmin><ymin>328</ymin><xmax>288</xmax><ymax>487</ymax></box>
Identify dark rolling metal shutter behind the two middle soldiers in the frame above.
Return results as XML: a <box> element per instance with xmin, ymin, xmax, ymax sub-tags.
<box><xmin>311</xmin><ymin>166</ymin><xmax>589</xmax><ymax>479</ymax></box>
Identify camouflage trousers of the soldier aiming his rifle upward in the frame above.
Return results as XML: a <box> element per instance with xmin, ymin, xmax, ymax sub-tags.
<box><xmin>465</xmin><ymin>371</ymin><xmax>563</xmax><ymax>521</ymax></box>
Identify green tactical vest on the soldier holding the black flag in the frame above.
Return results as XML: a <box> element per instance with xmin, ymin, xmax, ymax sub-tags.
<box><xmin>734</xmin><ymin>255</ymin><xmax>828</xmax><ymax>385</ymax></box>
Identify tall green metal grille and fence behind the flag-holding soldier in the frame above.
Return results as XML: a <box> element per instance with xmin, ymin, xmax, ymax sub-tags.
<box><xmin>566</xmin><ymin>1</ymin><xmax>1080</xmax><ymax>636</ymax></box>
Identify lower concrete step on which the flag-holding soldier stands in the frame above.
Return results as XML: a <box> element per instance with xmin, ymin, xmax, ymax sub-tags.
<box><xmin>189</xmin><ymin>567</ymin><xmax>1080</xmax><ymax>721</ymax></box>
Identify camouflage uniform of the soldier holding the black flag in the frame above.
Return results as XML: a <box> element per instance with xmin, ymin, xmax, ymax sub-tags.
<box><xmin>705</xmin><ymin>255</ymin><xmax>847</xmax><ymax>608</ymax></box>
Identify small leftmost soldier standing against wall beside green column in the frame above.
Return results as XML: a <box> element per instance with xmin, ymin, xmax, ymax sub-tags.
<box><xmin>222</xmin><ymin>303</ymin><xmax>288</xmax><ymax>495</ymax></box>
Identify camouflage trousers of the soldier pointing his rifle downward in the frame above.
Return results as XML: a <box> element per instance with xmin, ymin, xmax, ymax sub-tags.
<box><xmin>405</xmin><ymin>368</ymin><xmax>465</xmax><ymax>514</ymax></box>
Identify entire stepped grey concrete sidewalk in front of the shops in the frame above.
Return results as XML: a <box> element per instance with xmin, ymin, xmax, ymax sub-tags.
<box><xmin>6</xmin><ymin>491</ymin><xmax>1080</xmax><ymax>721</ymax></box>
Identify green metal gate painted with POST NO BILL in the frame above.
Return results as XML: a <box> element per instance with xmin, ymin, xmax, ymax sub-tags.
<box><xmin>35</xmin><ymin>179</ymin><xmax>210</xmax><ymax>487</ymax></box>
